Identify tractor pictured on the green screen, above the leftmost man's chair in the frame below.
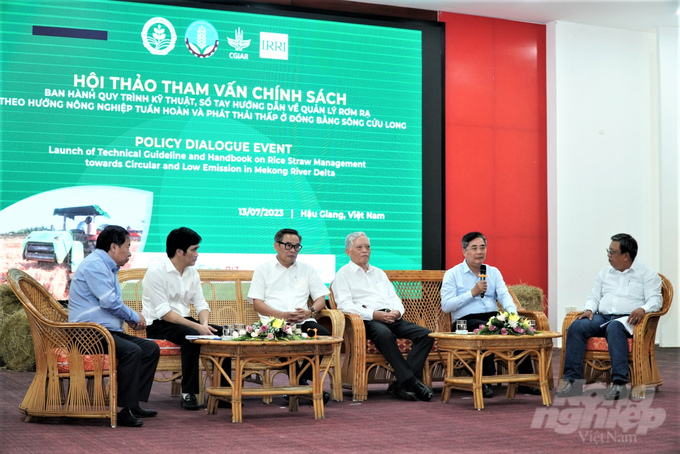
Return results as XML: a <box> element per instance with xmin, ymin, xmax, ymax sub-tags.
<box><xmin>23</xmin><ymin>205</ymin><xmax>109</xmax><ymax>271</ymax></box>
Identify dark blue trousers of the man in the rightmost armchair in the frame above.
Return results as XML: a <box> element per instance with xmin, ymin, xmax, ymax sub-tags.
<box><xmin>563</xmin><ymin>314</ymin><xmax>631</xmax><ymax>383</ymax></box>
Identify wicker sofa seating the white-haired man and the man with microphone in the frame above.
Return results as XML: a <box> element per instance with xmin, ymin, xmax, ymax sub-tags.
<box><xmin>330</xmin><ymin>270</ymin><xmax>552</xmax><ymax>401</ymax></box>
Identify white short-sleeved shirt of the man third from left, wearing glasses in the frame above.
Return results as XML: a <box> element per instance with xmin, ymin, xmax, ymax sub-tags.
<box><xmin>248</xmin><ymin>257</ymin><xmax>330</xmax><ymax>321</ymax></box>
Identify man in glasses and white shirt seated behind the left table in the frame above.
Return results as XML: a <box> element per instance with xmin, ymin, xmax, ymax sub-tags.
<box><xmin>248</xmin><ymin>229</ymin><xmax>331</xmax><ymax>403</ymax></box>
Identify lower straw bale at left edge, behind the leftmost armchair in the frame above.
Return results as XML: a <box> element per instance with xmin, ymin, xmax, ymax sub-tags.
<box><xmin>0</xmin><ymin>309</ymin><xmax>35</xmax><ymax>371</ymax></box>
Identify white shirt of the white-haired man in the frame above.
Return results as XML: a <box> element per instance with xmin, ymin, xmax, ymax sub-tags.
<box><xmin>331</xmin><ymin>262</ymin><xmax>404</xmax><ymax>320</ymax></box>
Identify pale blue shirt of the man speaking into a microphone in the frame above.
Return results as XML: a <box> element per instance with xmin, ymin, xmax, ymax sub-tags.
<box><xmin>441</xmin><ymin>260</ymin><xmax>517</xmax><ymax>320</ymax></box>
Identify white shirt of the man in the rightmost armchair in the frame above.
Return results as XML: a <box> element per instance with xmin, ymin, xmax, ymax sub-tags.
<box><xmin>584</xmin><ymin>262</ymin><xmax>661</xmax><ymax>315</ymax></box>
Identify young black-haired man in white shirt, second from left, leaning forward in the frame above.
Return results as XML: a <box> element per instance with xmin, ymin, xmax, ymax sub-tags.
<box><xmin>142</xmin><ymin>227</ymin><xmax>224</xmax><ymax>410</ymax></box>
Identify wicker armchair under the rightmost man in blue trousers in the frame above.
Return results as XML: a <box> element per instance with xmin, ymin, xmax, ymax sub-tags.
<box><xmin>560</xmin><ymin>274</ymin><xmax>673</xmax><ymax>398</ymax></box>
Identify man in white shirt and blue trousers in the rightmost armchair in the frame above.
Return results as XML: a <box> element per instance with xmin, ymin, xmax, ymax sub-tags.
<box><xmin>557</xmin><ymin>233</ymin><xmax>661</xmax><ymax>400</ymax></box>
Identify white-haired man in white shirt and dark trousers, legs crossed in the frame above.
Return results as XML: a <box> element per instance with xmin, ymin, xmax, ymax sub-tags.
<box><xmin>333</xmin><ymin>232</ymin><xmax>434</xmax><ymax>401</ymax></box>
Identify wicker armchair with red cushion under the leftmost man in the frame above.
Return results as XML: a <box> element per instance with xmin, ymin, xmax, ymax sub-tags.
<box><xmin>7</xmin><ymin>269</ymin><xmax>117</xmax><ymax>427</ymax></box>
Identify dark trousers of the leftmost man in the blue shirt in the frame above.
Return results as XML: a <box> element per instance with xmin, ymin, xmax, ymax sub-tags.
<box><xmin>111</xmin><ymin>331</ymin><xmax>161</xmax><ymax>408</ymax></box>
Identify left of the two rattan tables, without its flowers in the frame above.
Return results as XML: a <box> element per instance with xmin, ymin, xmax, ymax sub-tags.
<box><xmin>192</xmin><ymin>336</ymin><xmax>342</xmax><ymax>422</ymax></box>
